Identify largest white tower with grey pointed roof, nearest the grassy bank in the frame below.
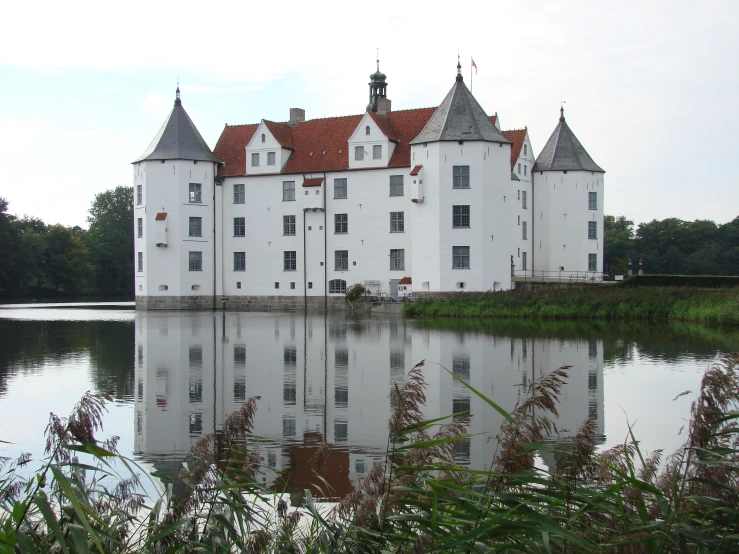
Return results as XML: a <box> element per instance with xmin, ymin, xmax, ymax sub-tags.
<box><xmin>411</xmin><ymin>64</ymin><xmax>513</xmax><ymax>292</ymax></box>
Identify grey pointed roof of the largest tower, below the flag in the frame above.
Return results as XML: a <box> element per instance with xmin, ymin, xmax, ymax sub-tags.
<box><xmin>411</xmin><ymin>63</ymin><xmax>511</xmax><ymax>144</ymax></box>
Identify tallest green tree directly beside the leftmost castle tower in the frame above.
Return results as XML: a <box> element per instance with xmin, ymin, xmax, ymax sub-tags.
<box><xmin>87</xmin><ymin>186</ymin><xmax>134</xmax><ymax>295</ymax></box>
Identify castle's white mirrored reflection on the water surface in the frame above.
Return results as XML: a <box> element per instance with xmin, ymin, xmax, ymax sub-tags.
<box><xmin>135</xmin><ymin>312</ymin><xmax>603</xmax><ymax>493</ymax></box>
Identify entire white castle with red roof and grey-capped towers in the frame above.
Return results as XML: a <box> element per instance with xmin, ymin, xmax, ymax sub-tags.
<box><xmin>133</xmin><ymin>64</ymin><xmax>605</xmax><ymax>309</ymax></box>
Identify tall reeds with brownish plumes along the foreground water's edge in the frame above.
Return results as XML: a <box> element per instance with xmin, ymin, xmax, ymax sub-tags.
<box><xmin>0</xmin><ymin>355</ymin><xmax>739</xmax><ymax>553</ymax></box>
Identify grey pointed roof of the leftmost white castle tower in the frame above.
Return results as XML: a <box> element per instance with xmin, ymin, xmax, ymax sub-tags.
<box><xmin>133</xmin><ymin>87</ymin><xmax>220</xmax><ymax>163</ymax></box>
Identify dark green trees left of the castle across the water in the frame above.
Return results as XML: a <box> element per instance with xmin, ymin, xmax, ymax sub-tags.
<box><xmin>0</xmin><ymin>186</ymin><xmax>134</xmax><ymax>298</ymax></box>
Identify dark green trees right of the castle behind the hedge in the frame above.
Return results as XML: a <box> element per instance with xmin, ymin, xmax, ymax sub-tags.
<box><xmin>604</xmin><ymin>215</ymin><xmax>739</xmax><ymax>275</ymax></box>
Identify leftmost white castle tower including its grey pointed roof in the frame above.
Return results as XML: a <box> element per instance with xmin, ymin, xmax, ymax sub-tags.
<box><xmin>133</xmin><ymin>87</ymin><xmax>221</xmax><ymax>309</ymax></box>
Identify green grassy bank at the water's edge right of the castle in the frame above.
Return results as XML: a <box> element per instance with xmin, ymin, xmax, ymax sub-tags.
<box><xmin>404</xmin><ymin>287</ymin><xmax>739</xmax><ymax>325</ymax></box>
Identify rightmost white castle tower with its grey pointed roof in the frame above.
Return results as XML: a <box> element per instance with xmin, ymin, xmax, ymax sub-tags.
<box><xmin>532</xmin><ymin>108</ymin><xmax>605</xmax><ymax>278</ymax></box>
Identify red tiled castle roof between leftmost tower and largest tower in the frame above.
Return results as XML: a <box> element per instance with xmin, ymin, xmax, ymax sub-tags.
<box><xmin>215</xmin><ymin>108</ymin><xmax>436</xmax><ymax>177</ymax></box>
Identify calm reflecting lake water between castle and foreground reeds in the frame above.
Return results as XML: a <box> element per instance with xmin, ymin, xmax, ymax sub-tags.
<box><xmin>0</xmin><ymin>306</ymin><xmax>739</xmax><ymax>493</ymax></box>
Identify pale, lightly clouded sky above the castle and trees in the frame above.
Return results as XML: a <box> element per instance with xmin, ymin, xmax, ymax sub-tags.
<box><xmin>0</xmin><ymin>0</ymin><xmax>739</xmax><ymax>227</ymax></box>
